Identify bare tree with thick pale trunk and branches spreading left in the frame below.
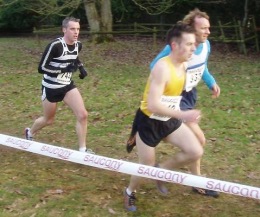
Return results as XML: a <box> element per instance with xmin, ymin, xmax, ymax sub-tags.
<box><xmin>0</xmin><ymin>0</ymin><xmax>113</xmax><ymax>42</ymax></box>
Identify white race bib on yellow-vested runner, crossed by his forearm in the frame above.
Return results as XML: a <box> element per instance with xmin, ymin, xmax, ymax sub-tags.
<box><xmin>150</xmin><ymin>96</ymin><xmax>181</xmax><ymax>121</ymax></box>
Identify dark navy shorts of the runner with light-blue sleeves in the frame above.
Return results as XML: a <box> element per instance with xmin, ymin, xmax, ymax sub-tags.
<box><xmin>180</xmin><ymin>87</ymin><xmax>197</xmax><ymax>111</ymax></box>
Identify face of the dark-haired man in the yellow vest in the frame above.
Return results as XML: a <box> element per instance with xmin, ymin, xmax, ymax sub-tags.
<box><xmin>174</xmin><ymin>33</ymin><xmax>196</xmax><ymax>62</ymax></box>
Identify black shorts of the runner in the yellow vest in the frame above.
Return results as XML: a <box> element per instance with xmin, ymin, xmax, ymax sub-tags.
<box><xmin>134</xmin><ymin>109</ymin><xmax>182</xmax><ymax>147</ymax></box>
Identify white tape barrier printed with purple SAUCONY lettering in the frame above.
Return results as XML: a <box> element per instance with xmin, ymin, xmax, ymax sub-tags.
<box><xmin>0</xmin><ymin>134</ymin><xmax>260</xmax><ymax>200</ymax></box>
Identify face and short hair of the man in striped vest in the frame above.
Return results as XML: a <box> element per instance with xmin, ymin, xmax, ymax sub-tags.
<box><xmin>63</xmin><ymin>21</ymin><xmax>80</xmax><ymax>44</ymax></box>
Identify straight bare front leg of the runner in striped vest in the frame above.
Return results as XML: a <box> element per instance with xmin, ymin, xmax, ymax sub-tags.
<box><xmin>64</xmin><ymin>88</ymin><xmax>88</xmax><ymax>148</ymax></box>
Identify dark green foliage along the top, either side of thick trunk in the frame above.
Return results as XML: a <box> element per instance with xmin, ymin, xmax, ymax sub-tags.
<box><xmin>0</xmin><ymin>0</ymin><xmax>260</xmax><ymax>33</ymax></box>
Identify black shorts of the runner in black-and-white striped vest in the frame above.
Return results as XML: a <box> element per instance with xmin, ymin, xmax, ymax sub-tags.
<box><xmin>42</xmin><ymin>81</ymin><xmax>76</xmax><ymax>102</ymax></box>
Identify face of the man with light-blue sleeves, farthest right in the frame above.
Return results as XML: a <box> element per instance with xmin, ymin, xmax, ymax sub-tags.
<box><xmin>194</xmin><ymin>17</ymin><xmax>210</xmax><ymax>44</ymax></box>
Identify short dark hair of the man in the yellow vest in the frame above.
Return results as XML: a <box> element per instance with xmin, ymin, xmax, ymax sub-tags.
<box><xmin>166</xmin><ymin>21</ymin><xmax>195</xmax><ymax>45</ymax></box>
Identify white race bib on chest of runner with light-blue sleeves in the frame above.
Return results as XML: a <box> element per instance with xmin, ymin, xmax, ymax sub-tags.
<box><xmin>185</xmin><ymin>64</ymin><xmax>205</xmax><ymax>92</ymax></box>
